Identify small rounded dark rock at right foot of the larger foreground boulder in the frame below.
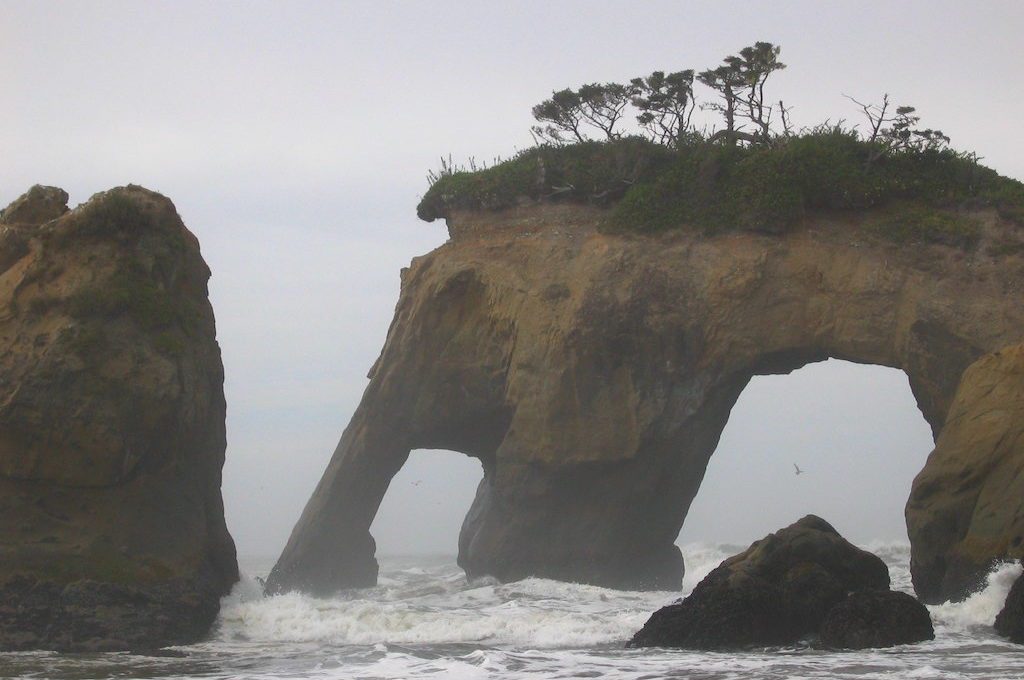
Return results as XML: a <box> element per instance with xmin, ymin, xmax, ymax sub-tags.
<box><xmin>819</xmin><ymin>590</ymin><xmax>935</xmax><ymax>649</ymax></box>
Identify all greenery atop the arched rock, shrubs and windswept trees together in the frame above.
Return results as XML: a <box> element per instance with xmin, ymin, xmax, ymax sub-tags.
<box><xmin>417</xmin><ymin>42</ymin><xmax>1024</xmax><ymax>248</ymax></box>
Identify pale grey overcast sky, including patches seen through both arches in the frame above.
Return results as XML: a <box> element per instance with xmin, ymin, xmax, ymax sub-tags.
<box><xmin>0</xmin><ymin>0</ymin><xmax>1024</xmax><ymax>555</ymax></box>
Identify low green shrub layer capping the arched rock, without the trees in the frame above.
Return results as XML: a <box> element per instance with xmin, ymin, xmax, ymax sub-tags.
<box><xmin>417</xmin><ymin>128</ymin><xmax>1024</xmax><ymax>248</ymax></box>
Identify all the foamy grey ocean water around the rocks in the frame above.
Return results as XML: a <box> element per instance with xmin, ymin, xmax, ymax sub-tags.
<box><xmin>0</xmin><ymin>544</ymin><xmax>1024</xmax><ymax>680</ymax></box>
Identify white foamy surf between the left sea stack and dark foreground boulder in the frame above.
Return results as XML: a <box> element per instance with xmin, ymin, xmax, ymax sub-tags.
<box><xmin>220</xmin><ymin>561</ymin><xmax>676</xmax><ymax>648</ymax></box>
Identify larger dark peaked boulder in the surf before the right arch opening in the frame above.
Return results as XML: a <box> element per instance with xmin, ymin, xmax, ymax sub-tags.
<box><xmin>630</xmin><ymin>515</ymin><xmax>888</xmax><ymax>649</ymax></box>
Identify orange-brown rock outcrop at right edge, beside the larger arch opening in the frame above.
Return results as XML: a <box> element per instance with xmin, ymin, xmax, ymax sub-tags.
<box><xmin>906</xmin><ymin>344</ymin><xmax>1024</xmax><ymax>602</ymax></box>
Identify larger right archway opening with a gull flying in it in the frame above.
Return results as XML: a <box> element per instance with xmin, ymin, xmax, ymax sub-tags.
<box><xmin>676</xmin><ymin>359</ymin><xmax>934</xmax><ymax>544</ymax></box>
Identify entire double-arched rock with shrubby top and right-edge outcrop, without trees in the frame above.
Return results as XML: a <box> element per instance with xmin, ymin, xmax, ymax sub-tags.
<box><xmin>268</xmin><ymin>131</ymin><xmax>1024</xmax><ymax>602</ymax></box>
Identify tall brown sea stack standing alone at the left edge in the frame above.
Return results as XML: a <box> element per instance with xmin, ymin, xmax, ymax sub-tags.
<box><xmin>0</xmin><ymin>186</ymin><xmax>238</xmax><ymax>650</ymax></box>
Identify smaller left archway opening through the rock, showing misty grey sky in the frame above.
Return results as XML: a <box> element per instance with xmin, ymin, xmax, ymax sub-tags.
<box><xmin>370</xmin><ymin>450</ymin><xmax>483</xmax><ymax>557</ymax></box>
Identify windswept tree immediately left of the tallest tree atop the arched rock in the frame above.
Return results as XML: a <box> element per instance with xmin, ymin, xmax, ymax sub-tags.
<box><xmin>630</xmin><ymin>70</ymin><xmax>695</xmax><ymax>147</ymax></box>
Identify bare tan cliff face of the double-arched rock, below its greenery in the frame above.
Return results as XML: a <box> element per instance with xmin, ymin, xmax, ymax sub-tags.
<box><xmin>269</xmin><ymin>205</ymin><xmax>1024</xmax><ymax>599</ymax></box>
